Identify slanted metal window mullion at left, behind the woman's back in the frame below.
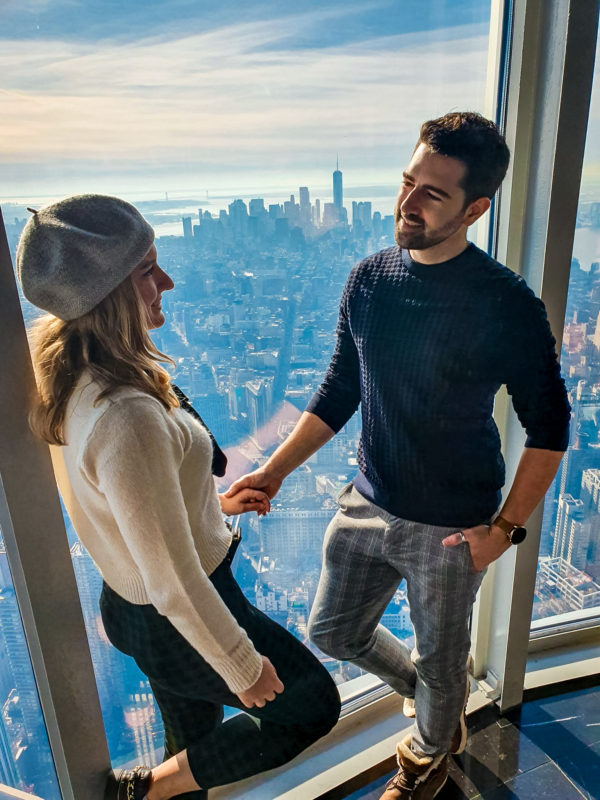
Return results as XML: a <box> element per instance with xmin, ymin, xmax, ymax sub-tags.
<box><xmin>0</xmin><ymin>212</ymin><xmax>110</xmax><ymax>800</ymax></box>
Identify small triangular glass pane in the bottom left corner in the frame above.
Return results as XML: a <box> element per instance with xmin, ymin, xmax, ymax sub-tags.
<box><xmin>0</xmin><ymin>529</ymin><xmax>61</xmax><ymax>800</ymax></box>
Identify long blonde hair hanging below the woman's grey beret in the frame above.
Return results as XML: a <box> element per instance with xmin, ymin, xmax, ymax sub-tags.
<box><xmin>29</xmin><ymin>278</ymin><xmax>179</xmax><ymax>445</ymax></box>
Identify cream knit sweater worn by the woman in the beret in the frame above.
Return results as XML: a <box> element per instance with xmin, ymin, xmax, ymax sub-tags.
<box><xmin>52</xmin><ymin>377</ymin><xmax>262</xmax><ymax>692</ymax></box>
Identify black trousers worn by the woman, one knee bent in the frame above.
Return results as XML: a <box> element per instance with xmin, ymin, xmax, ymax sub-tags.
<box><xmin>100</xmin><ymin>554</ymin><xmax>340</xmax><ymax>800</ymax></box>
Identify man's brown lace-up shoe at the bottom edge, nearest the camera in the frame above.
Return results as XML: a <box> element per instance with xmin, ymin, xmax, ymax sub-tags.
<box><xmin>380</xmin><ymin>734</ymin><xmax>448</xmax><ymax>800</ymax></box>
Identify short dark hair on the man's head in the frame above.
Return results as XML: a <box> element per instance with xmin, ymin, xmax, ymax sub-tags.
<box><xmin>417</xmin><ymin>111</ymin><xmax>510</xmax><ymax>206</ymax></box>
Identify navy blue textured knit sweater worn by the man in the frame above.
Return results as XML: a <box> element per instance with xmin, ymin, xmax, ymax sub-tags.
<box><xmin>307</xmin><ymin>244</ymin><xmax>570</xmax><ymax>527</ymax></box>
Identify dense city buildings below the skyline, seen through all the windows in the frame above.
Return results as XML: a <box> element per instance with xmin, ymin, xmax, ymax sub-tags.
<box><xmin>0</xmin><ymin>175</ymin><xmax>600</xmax><ymax>788</ymax></box>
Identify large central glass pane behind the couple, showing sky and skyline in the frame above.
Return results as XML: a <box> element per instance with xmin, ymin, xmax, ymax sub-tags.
<box><xmin>1</xmin><ymin>0</ymin><xmax>490</xmax><ymax>764</ymax></box>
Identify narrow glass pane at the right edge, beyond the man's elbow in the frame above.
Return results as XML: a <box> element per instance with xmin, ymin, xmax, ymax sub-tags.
<box><xmin>533</xmin><ymin>28</ymin><xmax>600</xmax><ymax>628</ymax></box>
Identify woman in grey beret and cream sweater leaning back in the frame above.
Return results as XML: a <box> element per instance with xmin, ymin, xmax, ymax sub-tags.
<box><xmin>17</xmin><ymin>195</ymin><xmax>339</xmax><ymax>800</ymax></box>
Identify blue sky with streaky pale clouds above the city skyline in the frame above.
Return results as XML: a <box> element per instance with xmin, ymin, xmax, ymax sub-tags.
<box><xmin>0</xmin><ymin>0</ymin><xmax>489</xmax><ymax>200</ymax></box>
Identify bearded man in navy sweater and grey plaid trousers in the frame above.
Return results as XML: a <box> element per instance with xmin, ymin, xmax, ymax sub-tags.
<box><xmin>225</xmin><ymin>112</ymin><xmax>570</xmax><ymax>800</ymax></box>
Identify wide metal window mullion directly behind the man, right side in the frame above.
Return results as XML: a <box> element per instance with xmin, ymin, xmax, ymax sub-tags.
<box><xmin>479</xmin><ymin>0</ymin><xmax>598</xmax><ymax>710</ymax></box>
